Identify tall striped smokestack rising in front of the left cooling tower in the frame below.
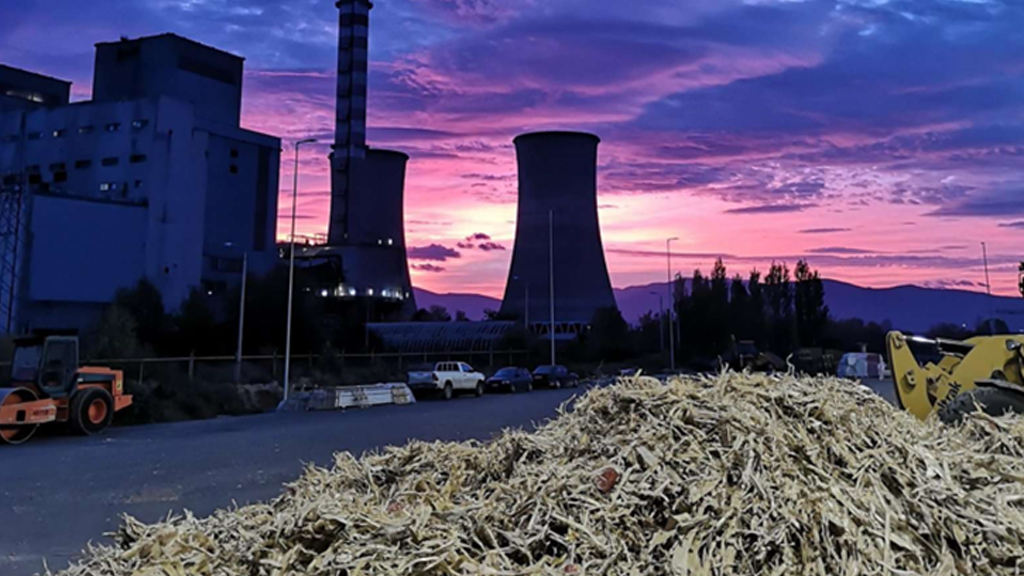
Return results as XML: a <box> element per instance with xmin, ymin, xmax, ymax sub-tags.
<box><xmin>328</xmin><ymin>0</ymin><xmax>374</xmax><ymax>246</ymax></box>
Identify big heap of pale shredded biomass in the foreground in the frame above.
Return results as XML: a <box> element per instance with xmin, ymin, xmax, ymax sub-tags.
<box><xmin>51</xmin><ymin>373</ymin><xmax>1024</xmax><ymax>576</ymax></box>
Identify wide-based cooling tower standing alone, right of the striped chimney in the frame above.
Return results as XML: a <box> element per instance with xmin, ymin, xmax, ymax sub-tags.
<box><xmin>502</xmin><ymin>132</ymin><xmax>615</xmax><ymax>331</ymax></box>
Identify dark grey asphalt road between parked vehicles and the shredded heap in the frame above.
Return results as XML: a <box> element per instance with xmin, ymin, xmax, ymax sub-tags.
<box><xmin>0</xmin><ymin>381</ymin><xmax>894</xmax><ymax>576</ymax></box>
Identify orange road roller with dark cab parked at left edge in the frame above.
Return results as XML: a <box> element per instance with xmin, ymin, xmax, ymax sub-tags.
<box><xmin>0</xmin><ymin>334</ymin><xmax>131</xmax><ymax>444</ymax></box>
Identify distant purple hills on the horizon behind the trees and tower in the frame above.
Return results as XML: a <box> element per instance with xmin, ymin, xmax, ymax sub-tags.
<box><xmin>416</xmin><ymin>280</ymin><xmax>1024</xmax><ymax>332</ymax></box>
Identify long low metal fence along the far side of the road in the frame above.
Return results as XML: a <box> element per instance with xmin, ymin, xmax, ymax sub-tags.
<box><xmin>0</xmin><ymin>351</ymin><xmax>530</xmax><ymax>383</ymax></box>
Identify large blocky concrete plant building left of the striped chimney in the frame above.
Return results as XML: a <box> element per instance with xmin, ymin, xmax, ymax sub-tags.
<box><xmin>0</xmin><ymin>34</ymin><xmax>281</xmax><ymax>332</ymax></box>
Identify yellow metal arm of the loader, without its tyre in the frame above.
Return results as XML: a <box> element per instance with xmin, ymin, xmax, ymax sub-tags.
<box><xmin>886</xmin><ymin>332</ymin><xmax>1024</xmax><ymax>420</ymax></box>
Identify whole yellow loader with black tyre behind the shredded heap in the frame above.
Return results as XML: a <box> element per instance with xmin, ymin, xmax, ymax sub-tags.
<box><xmin>886</xmin><ymin>262</ymin><xmax>1024</xmax><ymax>422</ymax></box>
